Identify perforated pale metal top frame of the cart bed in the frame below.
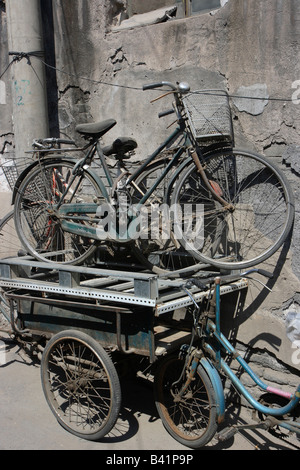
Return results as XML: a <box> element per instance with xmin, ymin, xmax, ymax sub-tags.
<box><xmin>0</xmin><ymin>257</ymin><xmax>248</xmax><ymax>316</ymax></box>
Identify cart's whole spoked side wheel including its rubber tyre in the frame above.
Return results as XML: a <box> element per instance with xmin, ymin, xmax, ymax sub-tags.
<box><xmin>41</xmin><ymin>330</ymin><xmax>121</xmax><ymax>441</ymax></box>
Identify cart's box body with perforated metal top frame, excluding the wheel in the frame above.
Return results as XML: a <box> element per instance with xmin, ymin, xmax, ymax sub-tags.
<box><xmin>0</xmin><ymin>256</ymin><xmax>248</xmax><ymax>362</ymax></box>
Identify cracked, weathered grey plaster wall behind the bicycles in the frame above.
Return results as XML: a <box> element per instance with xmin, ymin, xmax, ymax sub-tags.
<box><xmin>0</xmin><ymin>0</ymin><xmax>300</xmax><ymax>374</ymax></box>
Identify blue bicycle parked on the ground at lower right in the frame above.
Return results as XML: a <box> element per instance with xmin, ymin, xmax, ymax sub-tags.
<box><xmin>154</xmin><ymin>268</ymin><xmax>300</xmax><ymax>449</ymax></box>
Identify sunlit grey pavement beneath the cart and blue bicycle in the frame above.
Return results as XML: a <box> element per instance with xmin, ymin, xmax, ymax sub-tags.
<box><xmin>0</xmin><ymin>332</ymin><xmax>300</xmax><ymax>452</ymax></box>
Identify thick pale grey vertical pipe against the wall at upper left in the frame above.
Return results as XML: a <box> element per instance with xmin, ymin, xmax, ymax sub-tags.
<box><xmin>6</xmin><ymin>0</ymin><xmax>49</xmax><ymax>166</ymax></box>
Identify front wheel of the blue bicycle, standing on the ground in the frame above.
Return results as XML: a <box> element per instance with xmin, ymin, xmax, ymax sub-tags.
<box><xmin>154</xmin><ymin>355</ymin><xmax>218</xmax><ymax>449</ymax></box>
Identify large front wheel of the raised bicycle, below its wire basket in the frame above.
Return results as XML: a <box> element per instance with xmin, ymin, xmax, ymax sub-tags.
<box><xmin>173</xmin><ymin>150</ymin><xmax>294</xmax><ymax>269</ymax></box>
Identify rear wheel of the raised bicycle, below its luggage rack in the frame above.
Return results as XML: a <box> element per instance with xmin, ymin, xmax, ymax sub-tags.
<box><xmin>15</xmin><ymin>159</ymin><xmax>101</xmax><ymax>264</ymax></box>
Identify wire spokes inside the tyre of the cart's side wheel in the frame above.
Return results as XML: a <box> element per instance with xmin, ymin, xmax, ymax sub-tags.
<box><xmin>42</xmin><ymin>340</ymin><xmax>118</xmax><ymax>433</ymax></box>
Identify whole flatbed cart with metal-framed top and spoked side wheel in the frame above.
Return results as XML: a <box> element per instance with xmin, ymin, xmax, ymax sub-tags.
<box><xmin>0</xmin><ymin>256</ymin><xmax>247</xmax><ymax>440</ymax></box>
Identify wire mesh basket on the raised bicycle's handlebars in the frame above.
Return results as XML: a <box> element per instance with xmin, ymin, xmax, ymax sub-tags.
<box><xmin>183</xmin><ymin>90</ymin><xmax>234</xmax><ymax>142</ymax></box>
